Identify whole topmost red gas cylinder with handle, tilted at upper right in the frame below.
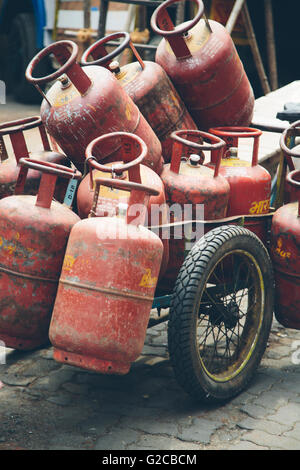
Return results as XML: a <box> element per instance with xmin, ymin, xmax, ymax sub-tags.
<box><xmin>151</xmin><ymin>0</ymin><xmax>254</xmax><ymax>130</ymax></box>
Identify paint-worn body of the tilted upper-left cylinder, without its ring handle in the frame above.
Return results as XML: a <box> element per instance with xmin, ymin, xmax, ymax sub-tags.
<box><xmin>41</xmin><ymin>66</ymin><xmax>163</xmax><ymax>173</ymax></box>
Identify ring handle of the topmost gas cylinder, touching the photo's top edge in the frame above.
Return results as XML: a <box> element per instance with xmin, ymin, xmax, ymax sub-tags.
<box><xmin>151</xmin><ymin>0</ymin><xmax>205</xmax><ymax>59</ymax></box>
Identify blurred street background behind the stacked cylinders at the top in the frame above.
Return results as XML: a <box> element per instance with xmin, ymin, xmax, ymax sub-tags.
<box><xmin>0</xmin><ymin>0</ymin><xmax>300</xmax><ymax>103</ymax></box>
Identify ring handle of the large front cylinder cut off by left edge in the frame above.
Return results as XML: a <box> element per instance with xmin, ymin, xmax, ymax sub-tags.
<box><xmin>15</xmin><ymin>158</ymin><xmax>82</xmax><ymax>209</ymax></box>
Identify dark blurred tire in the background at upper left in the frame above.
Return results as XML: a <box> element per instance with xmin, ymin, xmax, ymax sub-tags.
<box><xmin>5</xmin><ymin>13</ymin><xmax>49</xmax><ymax>104</ymax></box>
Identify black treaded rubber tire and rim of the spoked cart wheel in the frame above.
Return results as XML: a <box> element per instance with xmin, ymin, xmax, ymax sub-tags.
<box><xmin>168</xmin><ymin>226</ymin><xmax>274</xmax><ymax>402</ymax></box>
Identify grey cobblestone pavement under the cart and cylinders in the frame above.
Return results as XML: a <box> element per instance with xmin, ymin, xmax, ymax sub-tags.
<box><xmin>0</xmin><ymin>314</ymin><xmax>300</xmax><ymax>451</ymax></box>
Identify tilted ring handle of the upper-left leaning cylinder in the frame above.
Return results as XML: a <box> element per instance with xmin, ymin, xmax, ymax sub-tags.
<box><xmin>25</xmin><ymin>40</ymin><xmax>92</xmax><ymax>99</ymax></box>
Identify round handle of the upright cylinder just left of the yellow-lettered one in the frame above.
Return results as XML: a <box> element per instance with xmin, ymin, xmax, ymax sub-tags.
<box><xmin>170</xmin><ymin>130</ymin><xmax>226</xmax><ymax>178</ymax></box>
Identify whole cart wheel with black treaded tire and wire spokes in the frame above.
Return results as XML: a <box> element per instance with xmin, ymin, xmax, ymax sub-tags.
<box><xmin>168</xmin><ymin>226</ymin><xmax>274</xmax><ymax>401</ymax></box>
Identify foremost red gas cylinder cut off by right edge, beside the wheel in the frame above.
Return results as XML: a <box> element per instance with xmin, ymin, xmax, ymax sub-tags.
<box><xmin>270</xmin><ymin>170</ymin><xmax>300</xmax><ymax>329</ymax></box>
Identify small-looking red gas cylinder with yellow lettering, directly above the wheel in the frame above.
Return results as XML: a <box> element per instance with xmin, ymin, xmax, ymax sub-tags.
<box><xmin>208</xmin><ymin>127</ymin><xmax>271</xmax><ymax>243</ymax></box>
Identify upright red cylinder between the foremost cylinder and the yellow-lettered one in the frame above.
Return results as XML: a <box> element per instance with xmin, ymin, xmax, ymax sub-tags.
<box><xmin>158</xmin><ymin>130</ymin><xmax>230</xmax><ymax>292</ymax></box>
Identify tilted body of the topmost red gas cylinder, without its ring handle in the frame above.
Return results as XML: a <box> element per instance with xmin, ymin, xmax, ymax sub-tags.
<box><xmin>156</xmin><ymin>20</ymin><xmax>254</xmax><ymax>130</ymax></box>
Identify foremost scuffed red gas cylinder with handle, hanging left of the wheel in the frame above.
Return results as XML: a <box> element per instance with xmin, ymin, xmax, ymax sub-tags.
<box><xmin>49</xmin><ymin>178</ymin><xmax>163</xmax><ymax>374</ymax></box>
